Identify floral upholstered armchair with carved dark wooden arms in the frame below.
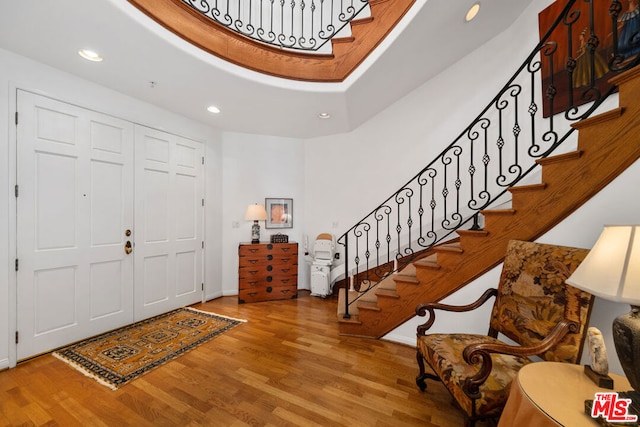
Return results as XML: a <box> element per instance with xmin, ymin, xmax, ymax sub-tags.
<box><xmin>416</xmin><ymin>240</ymin><xmax>594</xmax><ymax>426</ymax></box>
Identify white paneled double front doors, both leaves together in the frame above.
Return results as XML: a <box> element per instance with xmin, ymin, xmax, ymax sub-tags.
<box><xmin>16</xmin><ymin>91</ymin><xmax>204</xmax><ymax>360</ymax></box>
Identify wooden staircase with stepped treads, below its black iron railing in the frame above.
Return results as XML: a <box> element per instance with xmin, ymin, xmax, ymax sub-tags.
<box><xmin>338</xmin><ymin>67</ymin><xmax>640</xmax><ymax>338</ymax></box>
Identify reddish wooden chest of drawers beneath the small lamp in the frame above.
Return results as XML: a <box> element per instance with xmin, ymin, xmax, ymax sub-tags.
<box><xmin>238</xmin><ymin>242</ymin><xmax>298</xmax><ymax>304</ymax></box>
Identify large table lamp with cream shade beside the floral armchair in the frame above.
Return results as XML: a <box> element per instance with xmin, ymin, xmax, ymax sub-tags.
<box><xmin>567</xmin><ymin>225</ymin><xmax>640</xmax><ymax>404</ymax></box>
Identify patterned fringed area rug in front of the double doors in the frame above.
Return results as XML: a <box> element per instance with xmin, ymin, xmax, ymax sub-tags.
<box><xmin>53</xmin><ymin>308</ymin><xmax>245</xmax><ymax>390</ymax></box>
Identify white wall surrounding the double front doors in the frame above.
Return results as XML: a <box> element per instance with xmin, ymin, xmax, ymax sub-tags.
<box><xmin>0</xmin><ymin>49</ymin><xmax>222</xmax><ymax>369</ymax></box>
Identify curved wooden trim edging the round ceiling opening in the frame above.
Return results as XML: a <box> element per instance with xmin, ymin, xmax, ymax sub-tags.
<box><xmin>128</xmin><ymin>0</ymin><xmax>415</xmax><ymax>82</ymax></box>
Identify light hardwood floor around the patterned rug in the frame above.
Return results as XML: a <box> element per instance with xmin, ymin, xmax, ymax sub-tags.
<box><xmin>0</xmin><ymin>291</ymin><xmax>485</xmax><ymax>427</ymax></box>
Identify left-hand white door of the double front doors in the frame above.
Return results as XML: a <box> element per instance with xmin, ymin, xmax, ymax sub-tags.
<box><xmin>16</xmin><ymin>91</ymin><xmax>134</xmax><ymax>359</ymax></box>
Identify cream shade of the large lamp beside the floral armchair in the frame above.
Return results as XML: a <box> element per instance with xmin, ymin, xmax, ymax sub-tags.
<box><xmin>567</xmin><ymin>225</ymin><xmax>640</xmax><ymax>305</ymax></box>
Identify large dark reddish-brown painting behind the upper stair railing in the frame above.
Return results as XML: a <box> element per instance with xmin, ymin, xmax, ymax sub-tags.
<box><xmin>538</xmin><ymin>0</ymin><xmax>640</xmax><ymax>117</ymax></box>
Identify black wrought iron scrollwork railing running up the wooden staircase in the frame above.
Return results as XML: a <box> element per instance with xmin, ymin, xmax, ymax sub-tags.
<box><xmin>338</xmin><ymin>0</ymin><xmax>640</xmax><ymax>318</ymax></box>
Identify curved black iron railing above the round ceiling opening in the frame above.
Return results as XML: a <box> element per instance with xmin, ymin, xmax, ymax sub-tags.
<box><xmin>182</xmin><ymin>0</ymin><xmax>369</xmax><ymax>51</ymax></box>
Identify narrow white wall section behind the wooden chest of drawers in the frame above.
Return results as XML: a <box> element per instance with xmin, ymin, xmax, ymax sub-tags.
<box><xmin>221</xmin><ymin>133</ymin><xmax>309</xmax><ymax>295</ymax></box>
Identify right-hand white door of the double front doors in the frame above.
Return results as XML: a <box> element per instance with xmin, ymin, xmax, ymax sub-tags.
<box><xmin>135</xmin><ymin>126</ymin><xmax>204</xmax><ymax>319</ymax></box>
